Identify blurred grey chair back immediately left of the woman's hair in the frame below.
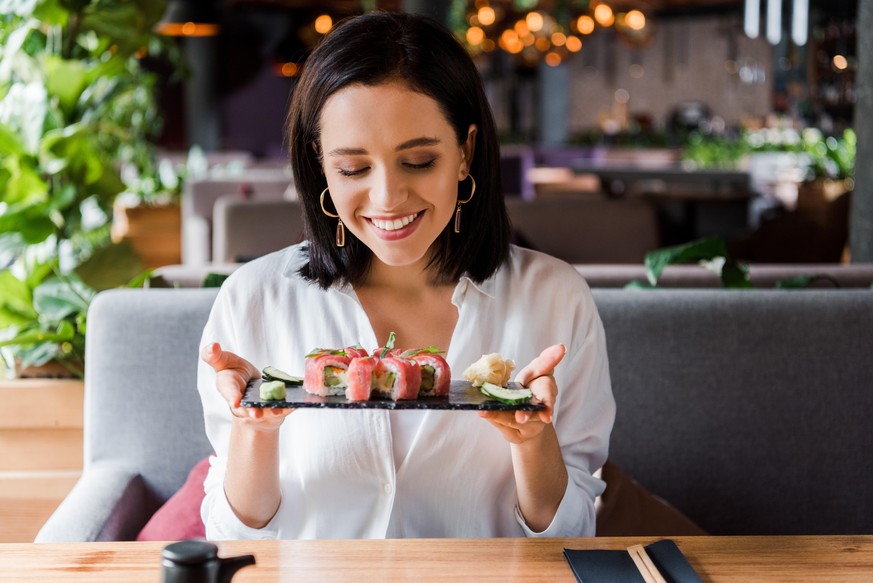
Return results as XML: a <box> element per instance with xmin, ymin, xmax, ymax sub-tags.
<box><xmin>212</xmin><ymin>196</ymin><xmax>303</xmax><ymax>263</ymax></box>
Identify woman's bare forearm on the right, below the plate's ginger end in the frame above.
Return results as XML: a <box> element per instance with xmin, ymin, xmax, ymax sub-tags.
<box><xmin>511</xmin><ymin>425</ymin><xmax>568</xmax><ymax>532</ymax></box>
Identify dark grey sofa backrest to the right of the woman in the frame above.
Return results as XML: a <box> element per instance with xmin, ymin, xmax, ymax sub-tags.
<box><xmin>594</xmin><ymin>289</ymin><xmax>873</xmax><ymax>534</ymax></box>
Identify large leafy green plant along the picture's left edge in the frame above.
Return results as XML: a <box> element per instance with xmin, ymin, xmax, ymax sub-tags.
<box><xmin>0</xmin><ymin>0</ymin><xmax>172</xmax><ymax>376</ymax></box>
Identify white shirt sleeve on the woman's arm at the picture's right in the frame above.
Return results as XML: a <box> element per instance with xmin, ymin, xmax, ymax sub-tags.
<box><xmin>516</xmin><ymin>282</ymin><xmax>615</xmax><ymax>537</ymax></box>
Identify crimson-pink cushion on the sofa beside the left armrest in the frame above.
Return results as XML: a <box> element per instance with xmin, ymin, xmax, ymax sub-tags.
<box><xmin>136</xmin><ymin>457</ymin><xmax>209</xmax><ymax>541</ymax></box>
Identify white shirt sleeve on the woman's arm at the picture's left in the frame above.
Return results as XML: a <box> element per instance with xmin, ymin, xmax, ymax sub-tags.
<box><xmin>197</xmin><ymin>280</ymin><xmax>278</xmax><ymax>540</ymax></box>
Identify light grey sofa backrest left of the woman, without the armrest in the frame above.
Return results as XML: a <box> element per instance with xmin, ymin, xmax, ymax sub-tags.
<box><xmin>84</xmin><ymin>289</ymin><xmax>217</xmax><ymax>500</ymax></box>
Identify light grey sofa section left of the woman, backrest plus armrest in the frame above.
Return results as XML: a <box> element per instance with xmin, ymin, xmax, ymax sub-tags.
<box><xmin>36</xmin><ymin>289</ymin><xmax>218</xmax><ymax>542</ymax></box>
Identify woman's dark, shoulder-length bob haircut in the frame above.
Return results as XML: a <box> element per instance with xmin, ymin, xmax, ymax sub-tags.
<box><xmin>286</xmin><ymin>12</ymin><xmax>510</xmax><ymax>289</ymax></box>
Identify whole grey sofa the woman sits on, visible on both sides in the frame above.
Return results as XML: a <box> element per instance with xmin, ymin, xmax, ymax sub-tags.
<box><xmin>37</xmin><ymin>289</ymin><xmax>873</xmax><ymax>542</ymax></box>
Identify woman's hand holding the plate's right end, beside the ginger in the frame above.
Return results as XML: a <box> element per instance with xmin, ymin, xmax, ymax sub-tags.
<box><xmin>479</xmin><ymin>344</ymin><xmax>567</xmax><ymax>444</ymax></box>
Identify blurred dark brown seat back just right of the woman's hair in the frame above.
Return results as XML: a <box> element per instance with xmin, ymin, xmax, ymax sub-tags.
<box><xmin>506</xmin><ymin>196</ymin><xmax>659</xmax><ymax>263</ymax></box>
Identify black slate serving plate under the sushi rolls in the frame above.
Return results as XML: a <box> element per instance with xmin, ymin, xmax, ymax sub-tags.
<box><xmin>241</xmin><ymin>379</ymin><xmax>545</xmax><ymax>411</ymax></box>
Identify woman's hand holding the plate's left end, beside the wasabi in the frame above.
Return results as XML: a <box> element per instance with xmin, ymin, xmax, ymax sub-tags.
<box><xmin>200</xmin><ymin>342</ymin><xmax>294</xmax><ymax>430</ymax></box>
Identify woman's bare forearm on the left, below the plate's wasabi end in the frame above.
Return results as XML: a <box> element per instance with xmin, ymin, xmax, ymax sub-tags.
<box><xmin>224</xmin><ymin>419</ymin><xmax>282</xmax><ymax>528</ymax></box>
